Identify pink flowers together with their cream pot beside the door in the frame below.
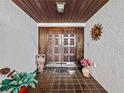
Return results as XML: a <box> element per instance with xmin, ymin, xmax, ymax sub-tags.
<box><xmin>80</xmin><ymin>59</ymin><xmax>91</xmax><ymax>78</ymax></box>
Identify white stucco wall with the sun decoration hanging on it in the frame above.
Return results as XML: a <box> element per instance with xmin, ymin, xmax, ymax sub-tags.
<box><xmin>85</xmin><ymin>0</ymin><xmax>124</xmax><ymax>93</ymax></box>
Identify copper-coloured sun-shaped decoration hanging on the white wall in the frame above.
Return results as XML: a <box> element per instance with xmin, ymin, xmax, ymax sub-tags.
<box><xmin>91</xmin><ymin>24</ymin><xmax>103</xmax><ymax>41</ymax></box>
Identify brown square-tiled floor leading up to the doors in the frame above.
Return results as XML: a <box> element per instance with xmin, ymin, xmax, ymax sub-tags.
<box><xmin>28</xmin><ymin>68</ymin><xmax>108</xmax><ymax>93</ymax></box>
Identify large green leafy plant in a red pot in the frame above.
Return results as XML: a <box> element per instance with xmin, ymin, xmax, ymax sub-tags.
<box><xmin>0</xmin><ymin>72</ymin><xmax>38</xmax><ymax>93</ymax></box>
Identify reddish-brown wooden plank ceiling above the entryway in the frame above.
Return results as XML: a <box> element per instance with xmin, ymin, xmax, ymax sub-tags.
<box><xmin>12</xmin><ymin>0</ymin><xmax>108</xmax><ymax>23</ymax></box>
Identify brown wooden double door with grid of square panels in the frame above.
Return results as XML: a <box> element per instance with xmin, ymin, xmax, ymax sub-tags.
<box><xmin>46</xmin><ymin>28</ymin><xmax>76</xmax><ymax>65</ymax></box>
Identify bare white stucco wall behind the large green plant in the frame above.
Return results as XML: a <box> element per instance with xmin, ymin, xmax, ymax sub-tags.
<box><xmin>0</xmin><ymin>0</ymin><xmax>38</xmax><ymax>72</ymax></box>
